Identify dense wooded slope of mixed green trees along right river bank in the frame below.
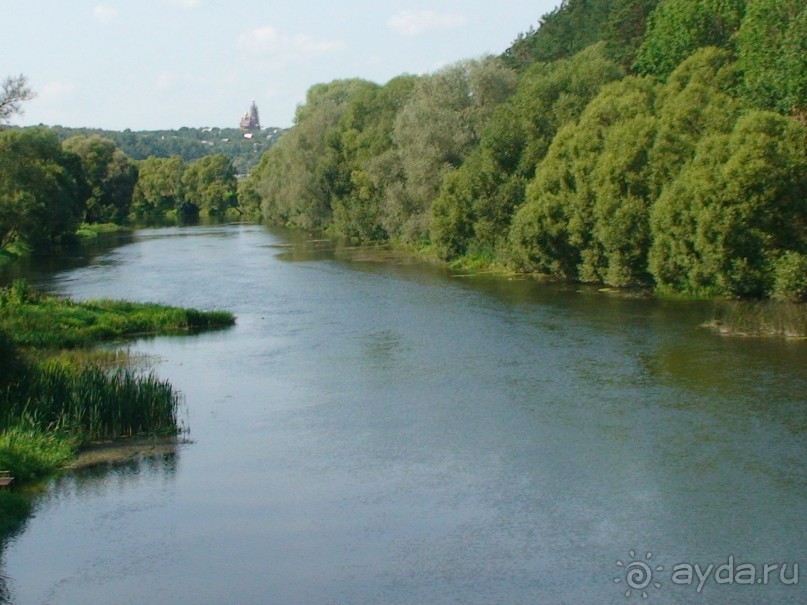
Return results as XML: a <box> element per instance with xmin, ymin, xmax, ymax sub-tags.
<box><xmin>242</xmin><ymin>0</ymin><xmax>807</xmax><ymax>300</ymax></box>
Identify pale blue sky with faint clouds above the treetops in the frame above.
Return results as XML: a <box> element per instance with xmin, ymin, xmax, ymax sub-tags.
<box><xmin>0</xmin><ymin>0</ymin><xmax>560</xmax><ymax>130</ymax></box>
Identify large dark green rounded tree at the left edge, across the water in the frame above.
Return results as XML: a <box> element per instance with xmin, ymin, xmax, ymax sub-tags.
<box><xmin>0</xmin><ymin>129</ymin><xmax>88</xmax><ymax>250</ymax></box>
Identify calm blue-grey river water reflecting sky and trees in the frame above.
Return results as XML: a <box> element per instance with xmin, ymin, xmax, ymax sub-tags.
<box><xmin>0</xmin><ymin>225</ymin><xmax>807</xmax><ymax>605</ymax></box>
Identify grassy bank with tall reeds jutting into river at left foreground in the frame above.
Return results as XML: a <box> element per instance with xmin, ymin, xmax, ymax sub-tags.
<box><xmin>0</xmin><ymin>281</ymin><xmax>235</xmax><ymax>537</ymax></box>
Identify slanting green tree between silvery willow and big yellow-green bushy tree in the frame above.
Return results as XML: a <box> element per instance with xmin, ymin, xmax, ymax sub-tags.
<box><xmin>431</xmin><ymin>45</ymin><xmax>623</xmax><ymax>259</ymax></box>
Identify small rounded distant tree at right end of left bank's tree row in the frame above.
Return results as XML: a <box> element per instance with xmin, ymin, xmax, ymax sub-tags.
<box><xmin>181</xmin><ymin>154</ymin><xmax>238</xmax><ymax>215</ymax></box>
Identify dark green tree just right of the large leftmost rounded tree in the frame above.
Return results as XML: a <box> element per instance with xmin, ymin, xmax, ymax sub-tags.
<box><xmin>63</xmin><ymin>136</ymin><xmax>137</xmax><ymax>224</ymax></box>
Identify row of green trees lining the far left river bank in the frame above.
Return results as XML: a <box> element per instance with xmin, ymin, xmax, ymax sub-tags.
<box><xmin>0</xmin><ymin>128</ymin><xmax>238</xmax><ymax>251</ymax></box>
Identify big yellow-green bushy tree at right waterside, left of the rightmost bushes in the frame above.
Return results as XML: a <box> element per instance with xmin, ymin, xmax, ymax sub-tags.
<box><xmin>511</xmin><ymin>78</ymin><xmax>657</xmax><ymax>286</ymax></box>
